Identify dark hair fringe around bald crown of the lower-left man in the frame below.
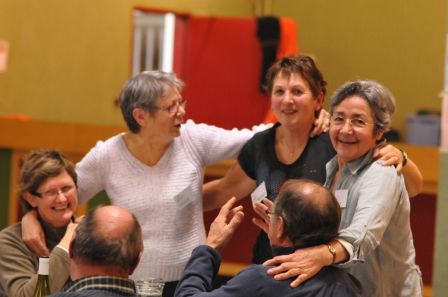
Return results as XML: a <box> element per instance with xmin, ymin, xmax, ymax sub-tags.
<box><xmin>70</xmin><ymin>206</ymin><xmax>143</xmax><ymax>272</ymax></box>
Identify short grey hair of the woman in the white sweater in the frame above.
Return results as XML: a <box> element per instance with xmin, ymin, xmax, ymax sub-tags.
<box><xmin>119</xmin><ymin>70</ymin><xmax>184</xmax><ymax>133</ymax></box>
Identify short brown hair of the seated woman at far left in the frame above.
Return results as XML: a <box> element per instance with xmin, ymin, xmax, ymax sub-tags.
<box><xmin>18</xmin><ymin>150</ymin><xmax>77</xmax><ymax>211</ymax></box>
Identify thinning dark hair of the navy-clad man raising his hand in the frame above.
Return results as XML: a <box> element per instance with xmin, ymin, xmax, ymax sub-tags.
<box><xmin>274</xmin><ymin>180</ymin><xmax>341</xmax><ymax>248</ymax></box>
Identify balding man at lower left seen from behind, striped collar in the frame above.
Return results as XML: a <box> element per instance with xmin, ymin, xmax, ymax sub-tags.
<box><xmin>52</xmin><ymin>205</ymin><xmax>143</xmax><ymax>297</ymax></box>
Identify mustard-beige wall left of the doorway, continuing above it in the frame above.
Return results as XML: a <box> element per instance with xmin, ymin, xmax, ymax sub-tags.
<box><xmin>0</xmin><ymin>0</ymin><xmax>251</xmax><ymax>124</ymax></box>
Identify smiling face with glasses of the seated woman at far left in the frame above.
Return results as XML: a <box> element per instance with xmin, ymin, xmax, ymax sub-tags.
<box><xmin>24</xmin><ymin>170</ymin><xmax>78</xmax><ymax>228</ymax></box>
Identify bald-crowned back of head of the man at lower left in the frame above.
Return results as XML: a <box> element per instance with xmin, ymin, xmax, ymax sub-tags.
<box><xmin>70</xmin><ymin>205</ymin><xmax>143</xmax><ymax>274</ymax></box>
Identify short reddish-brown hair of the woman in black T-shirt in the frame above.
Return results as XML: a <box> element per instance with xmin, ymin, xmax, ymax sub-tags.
<box><xmin>265</xmin><ymin>55</ymin><xmax>327</xmax><ymax>97</ymax></box>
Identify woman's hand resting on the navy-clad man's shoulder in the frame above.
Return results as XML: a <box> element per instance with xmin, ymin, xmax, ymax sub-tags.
<box><xmin>263</xmin><ymin>245</ymin><xmax>331</xmax><ymax>288</ymax></box>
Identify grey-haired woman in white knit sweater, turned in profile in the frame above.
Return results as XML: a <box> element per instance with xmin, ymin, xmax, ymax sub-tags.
<box><xmin>21</xmin><ymin>71</ymin><xmax>316</xmax><ymax>296</ymax></box>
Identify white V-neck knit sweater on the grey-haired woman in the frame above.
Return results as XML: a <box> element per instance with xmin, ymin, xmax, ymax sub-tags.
<box><xmin>76</xmin><ymin>121</ymin><xmax>262</xmax><ymax>281</ymax></box>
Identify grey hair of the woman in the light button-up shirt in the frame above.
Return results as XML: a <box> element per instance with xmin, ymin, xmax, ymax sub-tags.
<box><xmin>330</xmin><ymin>80</ymin><xmax>395</xmax><ymax>135</ymax></box>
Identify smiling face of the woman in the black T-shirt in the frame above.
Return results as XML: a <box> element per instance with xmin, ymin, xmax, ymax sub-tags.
<box><xmin>271</xmin><ymin>72</ymin><xmax>323</xmax><ymax>130</ymax></box>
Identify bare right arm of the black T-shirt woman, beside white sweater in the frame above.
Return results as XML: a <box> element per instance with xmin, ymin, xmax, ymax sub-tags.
<box><xmin>202</xmin><ymin>162</ymin><xmax>256</xmax><ymax>211</ymax></box>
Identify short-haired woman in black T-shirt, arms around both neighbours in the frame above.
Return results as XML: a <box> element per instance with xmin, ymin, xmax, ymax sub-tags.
<box><xmin>204</xmin><ymin>55</ymin><xmax>422</xmax><ymax>264</ymax></box>
